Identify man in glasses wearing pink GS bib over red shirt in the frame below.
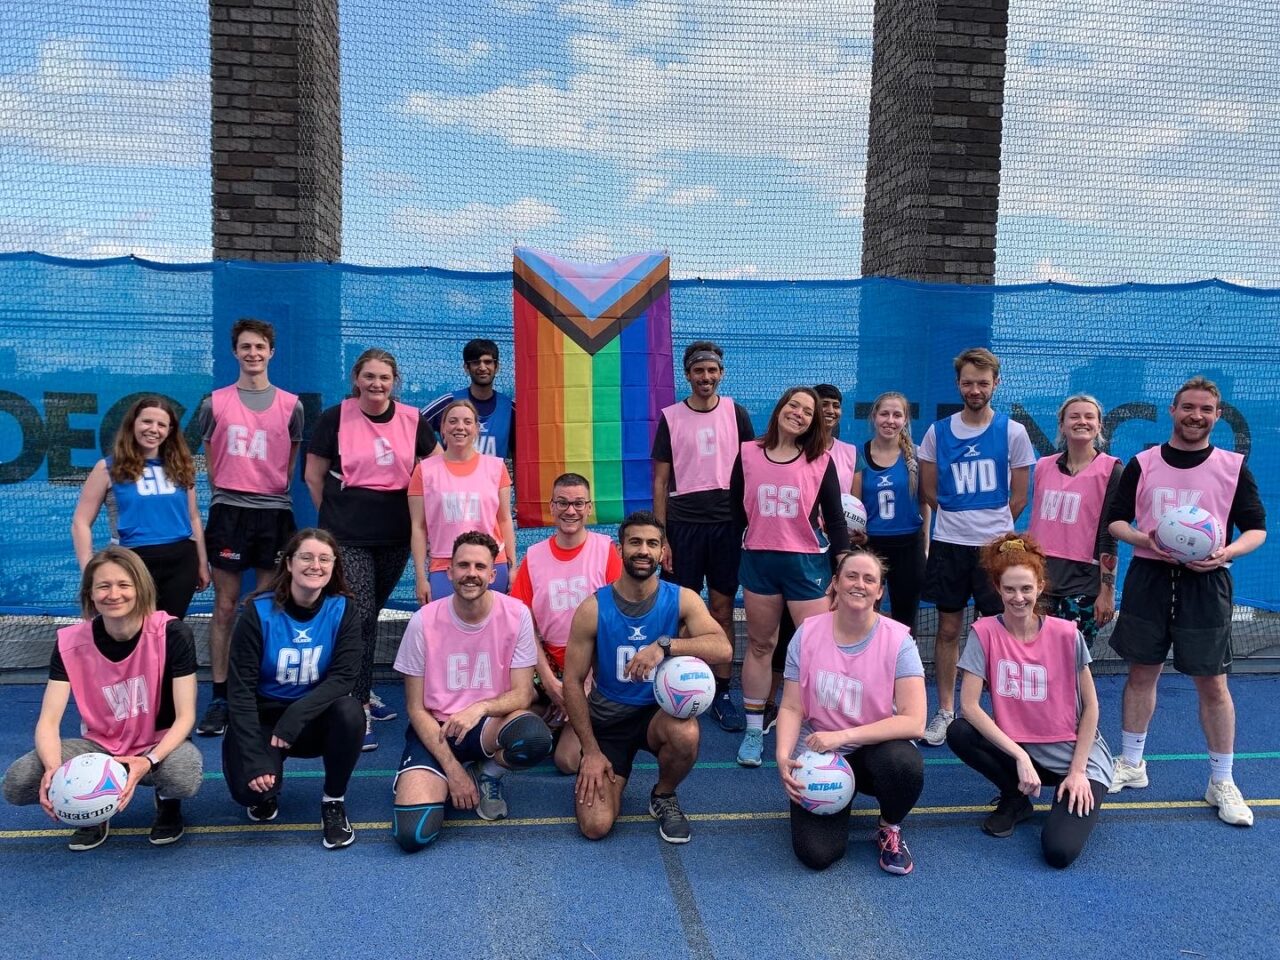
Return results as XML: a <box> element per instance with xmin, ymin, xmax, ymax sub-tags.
<box><xmin>509</xmin><ymin>474</ymin><xmax>622</xmax><ymax>773</ymax></box>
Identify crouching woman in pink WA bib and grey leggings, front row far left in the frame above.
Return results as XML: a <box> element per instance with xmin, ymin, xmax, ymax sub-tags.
<box><xmin>4</xmin><ymin>547</ymin><xmax>204</xmax><ymax>851</ymax></box>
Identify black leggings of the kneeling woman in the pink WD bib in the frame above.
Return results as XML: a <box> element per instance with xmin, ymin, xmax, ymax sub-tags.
<box><xmin>791</xmin><ymin>740</ymin><xmax>924</xmax><ymax>870</ymax></box>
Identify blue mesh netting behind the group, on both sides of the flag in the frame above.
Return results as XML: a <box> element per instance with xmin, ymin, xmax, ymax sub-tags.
<box><xmin>0</xmin><ymin>255</ymin><xmax>1280</xmax><ymax>640</ymax></box>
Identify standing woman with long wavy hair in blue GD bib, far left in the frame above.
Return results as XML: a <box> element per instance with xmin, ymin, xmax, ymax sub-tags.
<box><xmin>72</xmin><ymin>396</ymin><xmax>209</xmax><ymax>620</ymax></box>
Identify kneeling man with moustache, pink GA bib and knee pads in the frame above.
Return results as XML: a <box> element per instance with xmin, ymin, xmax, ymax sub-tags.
<box><xmin>392</xmin><ymin>531</ymin><xmax>552</xmax><ymax>852</ymax></box>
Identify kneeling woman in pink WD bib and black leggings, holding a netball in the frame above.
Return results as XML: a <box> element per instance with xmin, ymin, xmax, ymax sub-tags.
<box><xmin>777</xmin><ymin>548</ymin><xmax>927</xmax><ymax>876</ymax></box>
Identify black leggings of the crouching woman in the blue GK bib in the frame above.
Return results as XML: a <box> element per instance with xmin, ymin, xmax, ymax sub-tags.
<box><xmin>223</xmin><ymin>696</ymin><xmax>365</xmax><ymax>806</ymax></box>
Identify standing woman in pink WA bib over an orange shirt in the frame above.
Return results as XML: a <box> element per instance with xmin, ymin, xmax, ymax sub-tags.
<box><xmin>408</xmin><ymin>399</ymin><xmax>516</xmax><ymax>605</ymax></box>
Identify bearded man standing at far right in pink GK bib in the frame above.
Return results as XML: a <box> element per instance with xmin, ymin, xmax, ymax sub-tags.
<box><xmin>1108</xmin><ymin>376</ymin><xmax>1267</xmax><ymax>827</ymax></box>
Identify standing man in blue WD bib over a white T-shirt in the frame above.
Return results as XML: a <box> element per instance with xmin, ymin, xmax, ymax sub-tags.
<box><xmin>916</xmin><ymin>347</ymin><xmax>1036</xmax><ymax>746</ymax></box>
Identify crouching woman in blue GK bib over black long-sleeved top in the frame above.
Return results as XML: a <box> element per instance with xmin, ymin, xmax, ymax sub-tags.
<box><xmin>223</xmin><ymin>527</ymin><xmax>365</xmax><ymax>850</ymax></box>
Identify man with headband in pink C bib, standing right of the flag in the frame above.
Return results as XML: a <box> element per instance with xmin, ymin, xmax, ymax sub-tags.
<box><xmin>650</xmin><ymin>340</ymin><xmax>755</xmax><ymax>732</ymax></box>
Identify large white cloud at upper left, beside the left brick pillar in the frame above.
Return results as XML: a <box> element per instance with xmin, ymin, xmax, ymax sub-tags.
<box><xmin>0</xmin><ymin>38</ymin><xmax>211</xmax><ymax>166</ymax></box>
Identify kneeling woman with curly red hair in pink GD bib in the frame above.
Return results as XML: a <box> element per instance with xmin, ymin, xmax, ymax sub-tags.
<box><xmin>947</xmin><ymin>534</ymin><xmax>1114</xmax><ymax>868</ymax></box>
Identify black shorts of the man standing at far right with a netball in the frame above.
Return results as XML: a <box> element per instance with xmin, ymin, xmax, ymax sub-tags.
<box><xmin>1111</xmin><ymin>557</ymin><xmax>1231</xmax><ymax>677</ymax></box>
